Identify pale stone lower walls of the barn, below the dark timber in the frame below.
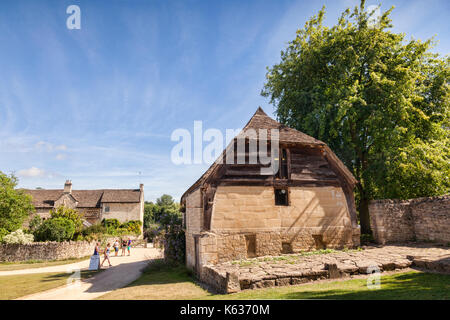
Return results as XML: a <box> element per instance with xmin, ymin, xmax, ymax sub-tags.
<box><xmin>186</xmin><ymin>186</ymin><xmax>360</xmax><ymax>272</ymax></box>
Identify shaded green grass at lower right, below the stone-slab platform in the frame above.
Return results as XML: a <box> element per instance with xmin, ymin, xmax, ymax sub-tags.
<box><xmin>279</xmin><ymin>272</ymin><xmax>450</xmax><ymax>300</ymax></box>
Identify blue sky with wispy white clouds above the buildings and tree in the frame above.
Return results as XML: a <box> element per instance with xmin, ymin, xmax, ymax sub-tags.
<box><xmin>0</xmin><ymin>0</ymin><xmax>450</xmax><ymax>200</ymax></box>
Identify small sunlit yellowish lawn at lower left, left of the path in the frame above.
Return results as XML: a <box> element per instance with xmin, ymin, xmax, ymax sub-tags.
<box><xmin>0</xmin><ymin>270</ymin><xmax>101</xmax><ymax>300</ymax></box>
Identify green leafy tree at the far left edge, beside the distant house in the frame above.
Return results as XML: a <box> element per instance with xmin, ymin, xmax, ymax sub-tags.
<box><xmin>0</xmin><ymin>171</ymin><xmax>34</xmax><ymax>232</ymax></box>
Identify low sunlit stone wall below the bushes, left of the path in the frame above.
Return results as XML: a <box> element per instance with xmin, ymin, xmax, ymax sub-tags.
<box><xmin>0</xmin><ymin>236</ymin><xmax>141</xmax><ymax>262</ymax></box>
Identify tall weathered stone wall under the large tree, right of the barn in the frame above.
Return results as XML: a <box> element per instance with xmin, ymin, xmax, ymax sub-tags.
<box><xmin>369</xmin><ymin>195</ymin><xmax>450</xmax><ymax>244</ymax></box>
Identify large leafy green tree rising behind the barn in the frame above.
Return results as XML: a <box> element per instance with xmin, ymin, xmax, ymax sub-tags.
<box><xmin>262</xmin><ymin>1</ymin><xmax>450</xmax><ymax>233</ymax></box>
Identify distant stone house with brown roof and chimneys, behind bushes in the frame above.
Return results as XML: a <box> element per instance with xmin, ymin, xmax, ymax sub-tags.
<box><xmin>24</xmin><ymin>180</ymin><xmax>144</xmax><ymax>225</ymax></box>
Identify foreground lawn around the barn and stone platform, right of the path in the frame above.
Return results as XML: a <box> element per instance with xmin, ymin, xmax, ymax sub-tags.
<box><xmin>100</xmin><ymin>262</ymin><xmax>450</xmax><ymax>300</ymax></box>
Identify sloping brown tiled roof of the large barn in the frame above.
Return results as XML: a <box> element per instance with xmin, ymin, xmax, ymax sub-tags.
<box><xmin>181</xmin><ymin>107</ymin><xmax>357</xmax><ymax>202</ymax></box>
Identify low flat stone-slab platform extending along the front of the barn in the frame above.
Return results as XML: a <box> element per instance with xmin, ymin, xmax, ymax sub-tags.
<box><xmin>199</xmin><ymin>243</ymin><xmax>450</xmax><ymax>293</ymax></box>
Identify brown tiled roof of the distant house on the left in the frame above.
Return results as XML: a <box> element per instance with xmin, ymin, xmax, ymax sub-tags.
<box><xmin>22</xmin><ymin>189</ymin><xmax>141</xmax><ymax>209</ymax></box>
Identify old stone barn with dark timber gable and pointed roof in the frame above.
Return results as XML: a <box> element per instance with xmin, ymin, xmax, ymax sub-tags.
<box><xmin>181</xmin><ymin>108</ymin><xmax>360</xmax><ymax>272</ymax></box>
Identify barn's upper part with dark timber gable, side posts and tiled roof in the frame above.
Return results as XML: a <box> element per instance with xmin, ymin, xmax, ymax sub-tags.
<box><xmin>181</xmin><ymin>108</ymin><xmax>358</xmax><ymax>231</ymax></box>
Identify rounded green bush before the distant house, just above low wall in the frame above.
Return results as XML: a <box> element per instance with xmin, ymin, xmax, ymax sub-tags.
<box><xmin>34</xmin><ymin>218</ymin><xmax>75</xmax><ymax>242</ymax></box>
